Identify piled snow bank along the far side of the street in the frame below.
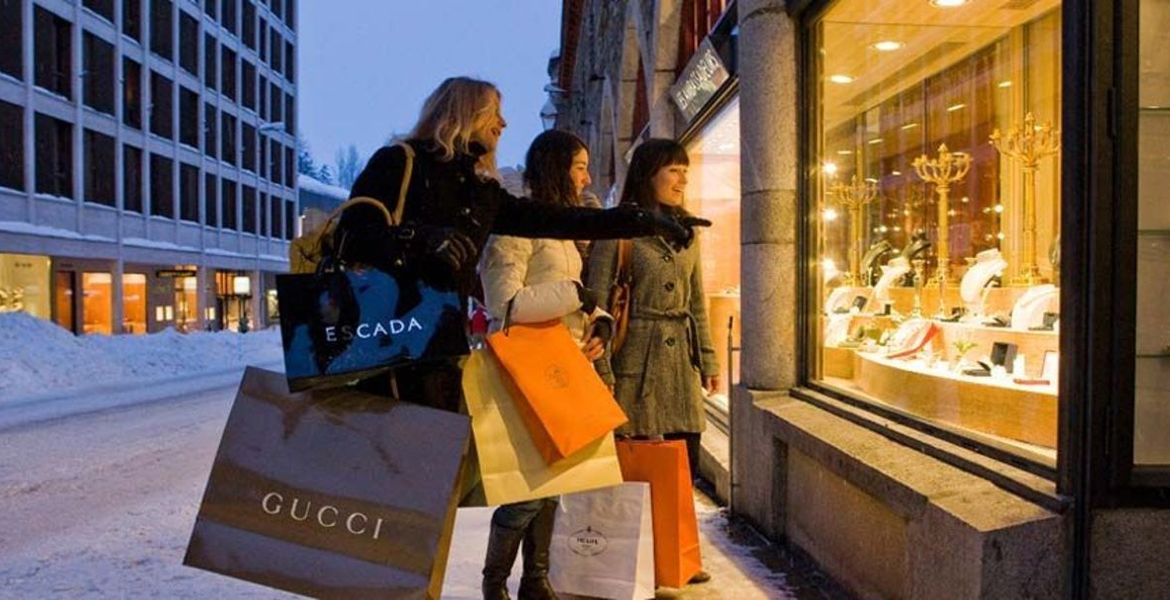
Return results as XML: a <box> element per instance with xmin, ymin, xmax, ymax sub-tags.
<box><xmin>0</xmin><ymin>312</ymin><xmax>281</xmax><ymax>401</ymax></box>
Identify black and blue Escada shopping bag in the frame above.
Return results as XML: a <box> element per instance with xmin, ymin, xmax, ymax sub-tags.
<box><xmin>276</xmin><ymin>269</ymin><xmax>468</xmax><ymax>392</ymax></box>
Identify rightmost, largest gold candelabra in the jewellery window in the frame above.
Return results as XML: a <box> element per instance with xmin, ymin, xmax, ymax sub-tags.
<box><xmin>991</xmin><ymin>112</ymin><xmax>1060</xmax><ymax>285</ymax></box>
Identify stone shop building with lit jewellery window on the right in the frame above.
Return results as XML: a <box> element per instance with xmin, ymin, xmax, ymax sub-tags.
<box><xmin>548</xmin><ymin>0</ymin><xmax>1170</xmax><ymax>598</ymax></box>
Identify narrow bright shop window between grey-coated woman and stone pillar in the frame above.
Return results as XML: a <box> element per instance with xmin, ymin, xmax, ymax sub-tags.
<box><xmin>687</xmin><ymin>98</ymin><xmax>739</xmax><ymax>411</ymax></box>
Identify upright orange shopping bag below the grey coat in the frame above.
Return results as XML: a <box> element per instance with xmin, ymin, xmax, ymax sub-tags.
<box><xmin>618</xmin><ymin>440</ymin><xmax>703</xmax><ymax>587</ymax></box>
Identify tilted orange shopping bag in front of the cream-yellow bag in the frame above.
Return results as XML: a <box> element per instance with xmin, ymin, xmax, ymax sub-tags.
<box><xmin>488</xmin><ymin>320</ymin><xmax>627</xmax><ymax>464</ymax></box>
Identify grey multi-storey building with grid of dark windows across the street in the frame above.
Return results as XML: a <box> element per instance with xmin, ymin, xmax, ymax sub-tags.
<box><xmin>0</xmin><ymin>0</ymin><xmax>298</xmax><ymax>335</ymax></box>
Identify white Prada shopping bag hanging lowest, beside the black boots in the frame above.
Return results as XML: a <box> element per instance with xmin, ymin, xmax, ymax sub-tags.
<box><xmin>549</xmin><ymin>482</ymin><xmax>654</xmax><ymax>600</ymax></box>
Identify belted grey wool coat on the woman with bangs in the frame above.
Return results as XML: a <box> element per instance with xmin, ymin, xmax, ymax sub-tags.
<box><xmin>587</xmin><ymin>233</ymin><xmax>720</xmax><ymax>435</ymax></box>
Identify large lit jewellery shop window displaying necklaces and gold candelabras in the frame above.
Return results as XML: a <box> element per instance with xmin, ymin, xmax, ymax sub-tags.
<box><xmin>805</xmin><ymin>0</ymin><xmax>1061</xmax><ymax>464</ymax></box>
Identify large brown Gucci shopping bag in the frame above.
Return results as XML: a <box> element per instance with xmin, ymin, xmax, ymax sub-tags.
<box><xmin>184</xmin><ymin>367</ymin><xmax>470</xmax><ymax>599</ymax></box>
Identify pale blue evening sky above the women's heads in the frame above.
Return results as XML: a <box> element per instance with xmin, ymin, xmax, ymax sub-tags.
<box><xmin>297</xmin><ymin>0</ymin><xmax>560</xmax><ymax>173</ymax></box>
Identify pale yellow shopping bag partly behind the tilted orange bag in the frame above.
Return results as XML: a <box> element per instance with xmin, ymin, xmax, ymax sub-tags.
<box><xmin>463</xmin><ymin>350</ymin><xmax>621</xmax><ymax>505</ymax></box>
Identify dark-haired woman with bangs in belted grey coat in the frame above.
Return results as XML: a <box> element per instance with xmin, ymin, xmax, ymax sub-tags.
<box><xmin>589</xmin><ymin>139</ymin><xmax>720</xmax><ymax>582</ymax></box>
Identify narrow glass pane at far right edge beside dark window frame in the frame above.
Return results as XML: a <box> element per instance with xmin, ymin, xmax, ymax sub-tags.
<box><xmin>1134</xmin><ymin>0</ymin><xmax>1170</xmax><ymax>464</ymax></box>
